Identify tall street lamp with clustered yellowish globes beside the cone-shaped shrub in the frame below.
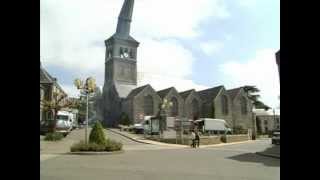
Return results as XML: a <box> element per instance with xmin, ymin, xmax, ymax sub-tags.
<box><xmin>74</xmin><ymin>77</ymin><xmax>96</xmax><ymax>144</ymax></box>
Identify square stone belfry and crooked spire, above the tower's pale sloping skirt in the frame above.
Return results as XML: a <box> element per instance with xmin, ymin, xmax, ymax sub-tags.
<box><xmin>105</xmin><ymin>0</ymin><xmax>139</xmax><ymax>85</ymax></box>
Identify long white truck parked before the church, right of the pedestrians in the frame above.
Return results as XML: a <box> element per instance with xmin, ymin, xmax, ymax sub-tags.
<box><xmin>195</xmin><ymin>118</ymin><xmax>232</xmax><ymax>134</ymax></box>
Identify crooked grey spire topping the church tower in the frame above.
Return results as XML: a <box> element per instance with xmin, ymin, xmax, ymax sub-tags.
<box><xmin>116</xmin><ymin>0</ymin><xmax>134</xmax><ymax>38</ymax></box>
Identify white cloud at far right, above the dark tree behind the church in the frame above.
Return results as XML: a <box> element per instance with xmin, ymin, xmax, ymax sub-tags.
<box><xmin>220</xmin><ymin>49</ymin><xmax>280</xmax><ymax>107</ymax></box>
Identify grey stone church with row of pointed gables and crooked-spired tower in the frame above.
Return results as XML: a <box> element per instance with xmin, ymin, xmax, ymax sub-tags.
<box><xmin>102</xmin><ymin>0</ymin><xmax>255</xmax><ymax>132</ymax></box>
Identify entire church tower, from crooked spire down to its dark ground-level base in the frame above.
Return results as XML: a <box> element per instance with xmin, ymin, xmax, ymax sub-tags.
<box><xmin>102</xmin><ymin>0</ymin><xmax>139</xmax><ymax>127</ymax></box>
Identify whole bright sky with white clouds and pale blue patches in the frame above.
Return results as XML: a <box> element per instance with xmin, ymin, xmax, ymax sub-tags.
<box><xmin>40</xmin><ymin>0</ymin><xmax>280</xmax><ymax>108</ymax></box>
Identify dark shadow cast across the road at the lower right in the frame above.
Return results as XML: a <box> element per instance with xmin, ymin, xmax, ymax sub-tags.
<box><xmin>228</xmin><ymin>153</ymin><xmax>280</xmax><ymax>167</ymax></box>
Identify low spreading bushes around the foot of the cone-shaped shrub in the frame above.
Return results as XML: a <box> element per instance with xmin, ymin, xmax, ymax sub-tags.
<box><xmin>70</xmin><ymin>139</ymin><xmax>122</xmax><ymax>152</ymax></box>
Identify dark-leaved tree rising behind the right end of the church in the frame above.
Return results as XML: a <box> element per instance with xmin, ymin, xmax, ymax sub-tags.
<box><xmin>243</xmin><ymin>85</ymin><xmax>271</xmax><ymax>110</ymax></box>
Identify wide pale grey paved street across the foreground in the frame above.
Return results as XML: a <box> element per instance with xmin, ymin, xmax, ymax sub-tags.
<box><xmin>40</xmin><ymin>129</ymin><xmax>280</xmax><ymax>180</ymax></box>
